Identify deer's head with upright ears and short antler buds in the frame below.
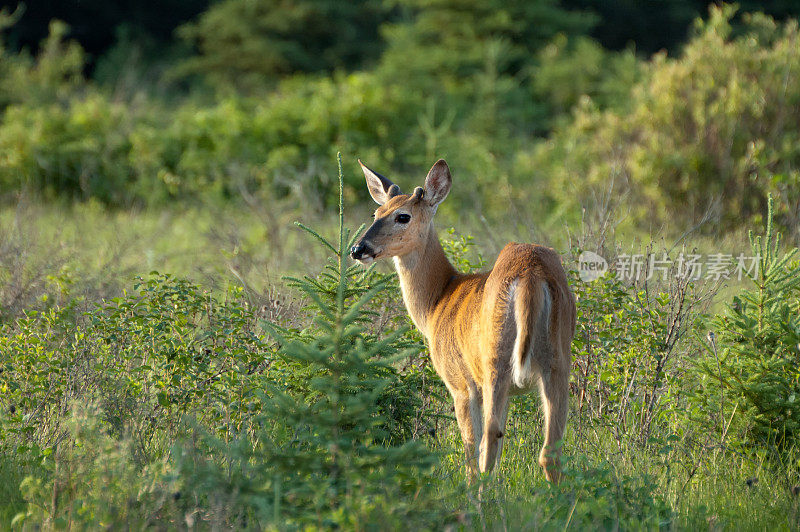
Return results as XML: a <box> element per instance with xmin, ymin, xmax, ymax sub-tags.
<box><xmin>350</xmin><ymin>159</ymin><xmax>452</xmax><ymax>264</ymax></box>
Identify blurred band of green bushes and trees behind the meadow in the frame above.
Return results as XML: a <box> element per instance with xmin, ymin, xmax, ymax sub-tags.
<box><xmin>0</xmin><ymin>0</ymin><xmax>800</xmax><ymax>241</ymax></box>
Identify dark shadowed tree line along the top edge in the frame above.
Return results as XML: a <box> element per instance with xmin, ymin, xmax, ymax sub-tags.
<box><xmin>6</xmin><ymin>0</ymin><xmax>800</xmax><ymax>75</ymax></box>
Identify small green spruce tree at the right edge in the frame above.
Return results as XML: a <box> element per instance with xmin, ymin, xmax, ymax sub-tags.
<box><xmin>694</xmin><ymin>198</ymin><xmax>800</xmax><ymax>449</ymax></box>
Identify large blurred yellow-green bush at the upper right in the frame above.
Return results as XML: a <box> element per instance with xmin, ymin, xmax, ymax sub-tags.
<box><xmin>531</xmin><ymin>6</ymin><xmax>800</xmax><ymax>231</ymax></box>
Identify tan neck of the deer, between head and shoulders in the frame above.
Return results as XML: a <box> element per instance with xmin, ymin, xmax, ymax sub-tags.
<box><xmin>394</xmin><ymin>224</ymin><xmax>456</xmax><ymax>336</ymax></box>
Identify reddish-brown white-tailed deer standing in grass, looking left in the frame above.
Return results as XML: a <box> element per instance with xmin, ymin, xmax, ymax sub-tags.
<box><xmin>351</xmin><ymin>159</ymin><xmax>575</xmax><ymax>482</ymax></box>
